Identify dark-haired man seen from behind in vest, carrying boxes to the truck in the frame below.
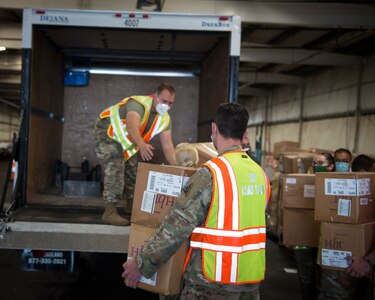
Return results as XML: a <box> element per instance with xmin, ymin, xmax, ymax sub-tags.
<box><xmin>122</xmin><ymin>103</ymin><xmax>270</xmax><ymax>300</ymax></box>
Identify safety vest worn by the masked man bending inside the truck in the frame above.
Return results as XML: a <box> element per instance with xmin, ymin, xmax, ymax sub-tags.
<box><xmin>100</xmin><ymin>96</ymin><xmax>170</xmax><ymax>160</ymax></box>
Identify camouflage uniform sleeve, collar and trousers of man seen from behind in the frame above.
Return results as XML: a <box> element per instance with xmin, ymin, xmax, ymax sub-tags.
<box><xmin>136</xmin><ymin>146</ymin><xmax>260</xmax><ymax>300</ymax></box>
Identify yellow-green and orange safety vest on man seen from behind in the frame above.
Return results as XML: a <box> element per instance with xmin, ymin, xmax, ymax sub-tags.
<box><xmin>191</xmin><ymin>150</ymin><xmax>270</xmax><ymax>284</ymax></box>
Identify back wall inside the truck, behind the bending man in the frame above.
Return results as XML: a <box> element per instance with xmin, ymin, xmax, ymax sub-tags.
<box><xmin>62</xmin><ymin>75</ymin><xmax>199</xmax><ymax>168</ymax></box>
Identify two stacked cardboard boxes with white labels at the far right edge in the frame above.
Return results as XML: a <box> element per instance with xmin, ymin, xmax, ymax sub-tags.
<box><xmin>315</xmin><ymin>172</ymin><xmax>375</xmax><ymax>271</ymax></box>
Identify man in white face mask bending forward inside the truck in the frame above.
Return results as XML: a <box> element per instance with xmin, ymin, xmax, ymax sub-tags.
<box><xmin>93</xmin><ymin>84</ymin><xmax>176</xmax><ymax>226</ymax></box>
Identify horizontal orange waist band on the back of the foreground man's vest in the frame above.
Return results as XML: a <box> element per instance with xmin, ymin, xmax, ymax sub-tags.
<box><xmin>190</xmin><ymin>232</ymin><xmax>266</xmax><ymax>247</ymax></box>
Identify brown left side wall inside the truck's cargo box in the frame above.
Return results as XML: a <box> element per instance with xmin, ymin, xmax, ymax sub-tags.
<box><xmin>27</xmin><ymin>31</ymin><xmax>64</xmax><ymax>199</ymax></box>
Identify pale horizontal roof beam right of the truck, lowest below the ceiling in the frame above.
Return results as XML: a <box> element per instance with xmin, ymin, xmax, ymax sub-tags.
<box><xmin>240</xmin><ymin>48</ymin><xmax>363</xmax><ymax>66</ymax></box>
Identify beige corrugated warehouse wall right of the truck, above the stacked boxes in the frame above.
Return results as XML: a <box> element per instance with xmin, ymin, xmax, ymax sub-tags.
<box><xmin>245</xmin><ymin>55</ymin><xmax>375</xmax><ymax>158</ymax></box>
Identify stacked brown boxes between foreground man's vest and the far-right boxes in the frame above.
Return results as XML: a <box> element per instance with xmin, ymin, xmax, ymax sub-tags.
<box><xmin>282</xmin><ymin>174</ymin><xmax>320</xmax><ymax>247</ymax></box>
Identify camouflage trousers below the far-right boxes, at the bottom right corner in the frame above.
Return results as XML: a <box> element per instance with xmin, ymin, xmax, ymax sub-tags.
<box><xmin>318</xmin><ymin>269</ymin><xmax>373</xmax><ymax>300</ymax></box>
